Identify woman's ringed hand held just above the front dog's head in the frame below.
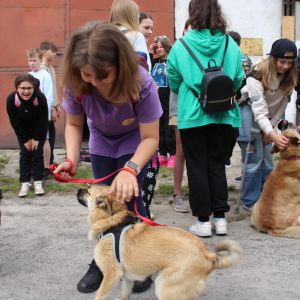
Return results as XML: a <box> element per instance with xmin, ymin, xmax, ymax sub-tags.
<box><xmin>107</xmin><ymin>171</ymin><xmax>139</xmax><ymax>203</ymax></box>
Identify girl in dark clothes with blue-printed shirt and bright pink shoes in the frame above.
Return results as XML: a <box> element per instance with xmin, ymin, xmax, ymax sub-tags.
<box><xmin>149</xmin><ymin>35</ymin><xmax>176</xmax><ymax>168</ymax></box>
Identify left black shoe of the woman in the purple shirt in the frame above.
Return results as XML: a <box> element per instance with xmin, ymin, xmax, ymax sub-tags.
<box><xmin>77</xmin><ymin>260</ymin><xmax>103</xmax><ymax>293</ymax></box>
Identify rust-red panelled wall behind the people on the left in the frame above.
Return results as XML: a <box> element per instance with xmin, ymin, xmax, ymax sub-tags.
<box><xmin>0</xmin><ymin>0</ymin><xmax>174</xmax><ymax>148</ymax></box>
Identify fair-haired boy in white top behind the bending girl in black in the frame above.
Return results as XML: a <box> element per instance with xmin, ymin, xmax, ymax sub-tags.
<box><xmin>27</xmin><ymin>48</ymin><xmax>53</xmax><ymax>179</ymax></box>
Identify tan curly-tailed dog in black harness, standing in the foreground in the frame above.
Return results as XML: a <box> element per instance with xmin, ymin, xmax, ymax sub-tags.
<box><xmin>77</xmin><ymin>184</ymin><xmax>243</xmax><ymax>300</ymax></box>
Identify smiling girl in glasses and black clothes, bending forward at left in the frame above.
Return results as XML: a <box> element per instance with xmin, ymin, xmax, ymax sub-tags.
<box><xmin>6</xmin><ymin>74</ymin><xmax>48</xmax><ymax>197</ymax></box>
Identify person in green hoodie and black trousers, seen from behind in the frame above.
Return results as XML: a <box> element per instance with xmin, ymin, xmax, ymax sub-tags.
<box><xmin>168</xmin><ymin>0</ymin><xmax>243</xmax><ymax>236</ymax></box>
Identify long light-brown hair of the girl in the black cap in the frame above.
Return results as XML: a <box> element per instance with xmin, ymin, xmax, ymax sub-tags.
<box><xmin>251</xmin><ymin>55</ymin><xmax>297</xmax><ymax>96</ymax></box>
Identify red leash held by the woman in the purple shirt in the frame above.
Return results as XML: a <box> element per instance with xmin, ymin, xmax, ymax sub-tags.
<box><xmin>49</xmin><ymin>165</ymin><xmax>166</xmax><ymax>226</ymax></box>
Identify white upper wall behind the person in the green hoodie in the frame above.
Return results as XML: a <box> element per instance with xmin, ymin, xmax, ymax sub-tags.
<box><xmin>175</xmin><ymin>0</ymin><xmax>282</xmax><ymax>63</ymax></box>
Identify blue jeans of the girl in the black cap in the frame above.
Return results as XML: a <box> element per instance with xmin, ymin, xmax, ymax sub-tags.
<box><xmin>237</xmin><ymin>104</ymin><xmax>273</xmax><ymax>208</ymax></box>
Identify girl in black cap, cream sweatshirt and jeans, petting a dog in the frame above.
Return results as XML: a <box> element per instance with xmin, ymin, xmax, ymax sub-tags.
<box><xmin>238</xmin><ymin>39</ymin><xmax>297</xmax><ymax>211</ymax></box>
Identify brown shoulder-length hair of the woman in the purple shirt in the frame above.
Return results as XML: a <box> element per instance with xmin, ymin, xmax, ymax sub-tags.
<box><xmin>62</xmin><ymin>21</ymin><xmax>142</xmax><ymax>105</ymax></box>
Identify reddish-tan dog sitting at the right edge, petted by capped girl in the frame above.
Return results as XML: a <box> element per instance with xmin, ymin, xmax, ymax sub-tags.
<box><xmin>251</xmin><ymin>129</ymin><xmax>300</xmax><ymax>239</ymax></box>
